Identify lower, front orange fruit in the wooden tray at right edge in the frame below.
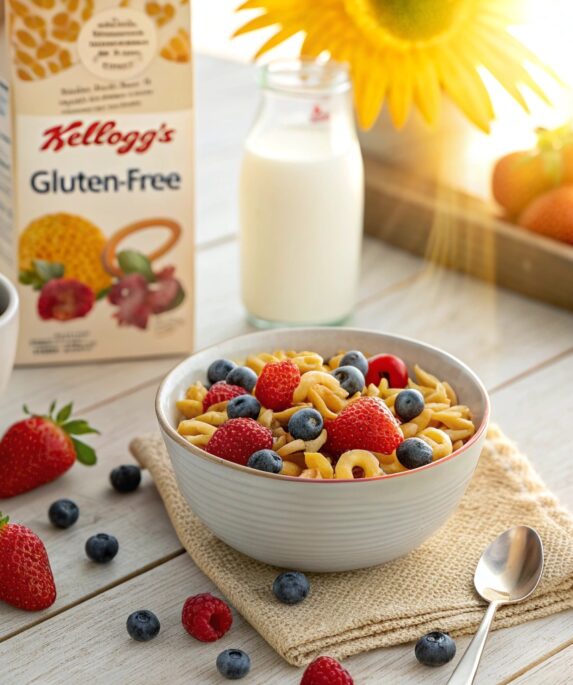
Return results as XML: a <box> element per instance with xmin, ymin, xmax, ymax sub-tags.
<box><xmin>519</xmin><ymin>185</ymin><xmax>573</xmax><ymax>245</ymax></box>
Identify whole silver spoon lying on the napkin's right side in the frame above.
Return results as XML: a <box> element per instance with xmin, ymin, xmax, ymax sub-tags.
<box><xmin>448</xmin><ymin>526</ymin><xmax>543</xmax><ymax>685</ymax></box>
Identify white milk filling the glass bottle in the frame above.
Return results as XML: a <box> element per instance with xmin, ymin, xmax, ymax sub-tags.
<box><xmin>240</xmin><ymin>125</ymin><xmax>364</xmax><ymax>324</ymax></box>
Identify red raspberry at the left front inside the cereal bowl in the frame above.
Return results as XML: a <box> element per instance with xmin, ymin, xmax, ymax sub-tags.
<box><xmin>205</xmin><ymin>419</ymin><xmax>273</xmax><ymax>466</ymax></box>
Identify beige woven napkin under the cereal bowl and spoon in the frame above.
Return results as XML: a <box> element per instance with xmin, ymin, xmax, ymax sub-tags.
<box><xmin>131</xmin><ymin>428</ymin><xmax>573</xmax><ymax>666</ymax></box>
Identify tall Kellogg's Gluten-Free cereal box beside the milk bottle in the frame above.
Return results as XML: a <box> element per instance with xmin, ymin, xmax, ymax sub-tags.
<box><xmin>0</xmin><ymin>0</ymin><xmax>193</xmax><ymax>364</ymax></box>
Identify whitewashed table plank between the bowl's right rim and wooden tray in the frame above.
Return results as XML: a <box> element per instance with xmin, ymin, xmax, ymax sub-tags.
<box><xmin>351</xmin><ymin>265</ymin><xmax>573</xmax><ymax>388</ymax></box>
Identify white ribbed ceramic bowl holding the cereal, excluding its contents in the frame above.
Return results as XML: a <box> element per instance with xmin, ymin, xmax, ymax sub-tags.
<box><xmin>156</xmin><ymin>328</ymin><xmax>489</xmax><ymax>571</ymax></box>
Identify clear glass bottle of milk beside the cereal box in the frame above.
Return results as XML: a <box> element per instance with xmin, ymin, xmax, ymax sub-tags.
<box><xmin>240</xmin><ymin>60</ymin><xmax>364</xmax><ymax>326</ymax></box>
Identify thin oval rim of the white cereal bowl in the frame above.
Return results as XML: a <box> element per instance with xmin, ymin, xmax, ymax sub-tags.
<box><xmin>155</xmin><ymin>326</ymin><xmax>491</xmax><ymax>485</ymax></box>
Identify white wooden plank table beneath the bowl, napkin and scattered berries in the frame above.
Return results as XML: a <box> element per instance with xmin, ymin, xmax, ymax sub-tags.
<box><xmin>0</xmin><ymin>58</ymin><xmax>573</xmax><ymax>685</ymax></box>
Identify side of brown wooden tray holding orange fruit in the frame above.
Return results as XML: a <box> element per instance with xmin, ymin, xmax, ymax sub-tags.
<box><xmin>365</xmin><ymin>158</ymin><xmax>573</xmax><ymax>310</ymax></box>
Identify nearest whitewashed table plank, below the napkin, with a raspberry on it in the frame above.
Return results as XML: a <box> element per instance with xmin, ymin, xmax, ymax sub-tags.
<box><xmin>0</xmin><ymin>555</ymin><xmax>573</xmax><ymax>685</ymax></box>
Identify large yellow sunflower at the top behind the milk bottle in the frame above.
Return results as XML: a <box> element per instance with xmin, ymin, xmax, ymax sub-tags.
<box><xmin>234</xmin><ymin>0</ymin><xmax>548</xmax><ymax>132</ymax></box>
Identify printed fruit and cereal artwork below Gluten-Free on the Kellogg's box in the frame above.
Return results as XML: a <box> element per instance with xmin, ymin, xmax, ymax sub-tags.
<box><xmin>20</xmin><ymin>214</ymin><xmax>185</xmax><ymax>330</ymax></box>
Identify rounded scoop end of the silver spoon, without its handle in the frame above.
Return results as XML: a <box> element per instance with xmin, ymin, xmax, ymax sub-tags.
<box><xmin>474</xmin><ymin>526</ymin><xmax>543</xmax><ymax>604</ymax></box>
